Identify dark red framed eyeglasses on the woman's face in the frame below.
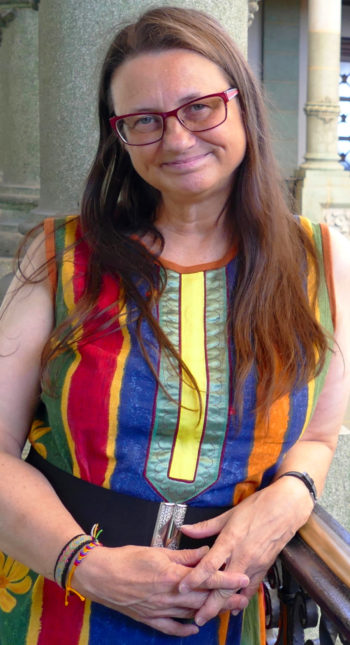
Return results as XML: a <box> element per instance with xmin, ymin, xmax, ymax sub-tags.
<box><xmin>109</xmin><ymin>88</ymin><xmax>238</xmax><ymax>146</ymax></box>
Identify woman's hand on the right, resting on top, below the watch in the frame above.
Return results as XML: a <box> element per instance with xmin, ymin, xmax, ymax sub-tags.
<box><xmin>179</xmin><ymin>477</ymin><xmax>313</xmax><ymax>626</ymax></box>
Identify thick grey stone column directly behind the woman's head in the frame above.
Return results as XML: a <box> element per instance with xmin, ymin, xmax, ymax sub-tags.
<box><xmin>32</xmin><ymin>0</ymin><xmax>248</xmax><ymax>219</ymax></box>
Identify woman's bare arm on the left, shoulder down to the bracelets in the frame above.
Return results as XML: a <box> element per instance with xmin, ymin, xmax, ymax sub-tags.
<box><xmin>0</xmin><ymin>236</ymin><xmax>85</xmax><ymax>578</ymax></box>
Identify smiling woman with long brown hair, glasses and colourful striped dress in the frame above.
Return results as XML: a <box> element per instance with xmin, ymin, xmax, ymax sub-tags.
<box><xmin>0</xmin><ymin>8</ymin><xmax>350</xmax><ymax>645</ymax></box>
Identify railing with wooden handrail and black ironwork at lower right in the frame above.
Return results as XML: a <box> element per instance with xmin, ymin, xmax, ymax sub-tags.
<box><xmin>264</xmin><ymin>504</ymin><xmax>350</xmax><ymax>645</ymax></box>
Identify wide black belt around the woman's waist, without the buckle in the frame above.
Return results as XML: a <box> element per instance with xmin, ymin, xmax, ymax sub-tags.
<box><xmin>26</xmin><ymin>448</ymin><xmax>231</xmax><ymax>549</ymax></box>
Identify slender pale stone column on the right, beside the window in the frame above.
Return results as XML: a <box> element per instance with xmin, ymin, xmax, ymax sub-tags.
<box><xmin>297</xmin><ymin>0</ymin><xmax>350</xmax><ymax>221</ymax></box>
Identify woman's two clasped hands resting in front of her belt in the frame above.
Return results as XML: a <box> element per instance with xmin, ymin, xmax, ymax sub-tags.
<box><xmin>76</xmin><ymin>480</ymin><xmax>300</xmax><ymax>637</ymax></box>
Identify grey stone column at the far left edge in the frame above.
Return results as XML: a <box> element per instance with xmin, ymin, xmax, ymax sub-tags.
<box><xmin>0</xmin><ymin>8</ymin><xmax>39</xmax><ymax>226</ymax></box>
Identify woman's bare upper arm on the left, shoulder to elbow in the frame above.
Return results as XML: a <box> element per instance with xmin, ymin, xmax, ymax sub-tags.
<box><xmin>0</xmin><ymin>235</ymin><xmax>54</xmax><ymax>454</ymax></box>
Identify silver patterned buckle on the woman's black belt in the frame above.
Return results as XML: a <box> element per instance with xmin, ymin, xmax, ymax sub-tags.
<box><xmin>151</xmin><ymin>502</ymin><xmax>187</xmax><ymax>549</ymax></box>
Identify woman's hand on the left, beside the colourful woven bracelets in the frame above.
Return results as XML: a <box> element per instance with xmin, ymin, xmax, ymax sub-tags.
<box><xmin>72</xmin><ymin>546</ymin><xmax>247</xmax><ymax>637</ymax></box>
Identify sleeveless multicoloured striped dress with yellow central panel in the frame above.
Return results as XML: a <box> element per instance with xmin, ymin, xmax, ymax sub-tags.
<box><xmin>0</xmin><ymin>217</ymin><xmax>334</xmax><ymax>645</ymax></box>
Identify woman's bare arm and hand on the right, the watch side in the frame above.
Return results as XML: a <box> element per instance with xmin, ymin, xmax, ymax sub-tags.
<box><xmin>180</xmin><ymin>226</ymin><xmax>350</xmax><ymax>624</ymax></box>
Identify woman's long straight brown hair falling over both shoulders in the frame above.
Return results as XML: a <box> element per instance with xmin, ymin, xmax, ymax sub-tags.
<box><xmin>39</xmin><ymin>7</ymin><xmax>328</xmax><ymax>412</ymax></box>
